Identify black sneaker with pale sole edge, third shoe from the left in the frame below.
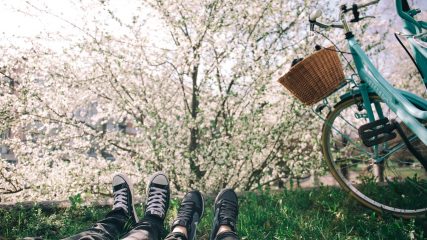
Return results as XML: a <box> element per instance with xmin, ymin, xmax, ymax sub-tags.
<box><xmin>171</xmin><ymin>190</ymin><xmax>205</xmax><ymax>240</ymax></box>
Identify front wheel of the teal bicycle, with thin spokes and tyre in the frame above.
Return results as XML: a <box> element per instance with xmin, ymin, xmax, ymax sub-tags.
<box><xmin>322</xmin><ymin>95</ymin><xmax>427</xmax><ymax>218</ymax></box>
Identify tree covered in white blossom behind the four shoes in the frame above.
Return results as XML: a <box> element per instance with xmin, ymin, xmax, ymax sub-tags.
<box><xmin>0</xmin><ymin>0</ymin><xmax>422</xmax><ymax>201</ymax></box>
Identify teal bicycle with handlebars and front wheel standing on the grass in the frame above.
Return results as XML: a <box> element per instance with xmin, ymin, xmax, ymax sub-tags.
<box><xmin>281</xmin><ymin>0</ymin><xmax>427</xmax><ymax>218</ymax></box>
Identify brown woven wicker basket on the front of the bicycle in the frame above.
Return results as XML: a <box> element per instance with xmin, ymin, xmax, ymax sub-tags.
<box><xmin>279</xmin><ymin>47</ymin><xmax>344</xmax><ymax>105</ymax></box>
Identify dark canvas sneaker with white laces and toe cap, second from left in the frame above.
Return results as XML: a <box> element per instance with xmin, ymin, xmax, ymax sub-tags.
<box><xmin>144</xmin><ymin>172</ymin><xmax>170</xmax><ymax>221</ymax></box>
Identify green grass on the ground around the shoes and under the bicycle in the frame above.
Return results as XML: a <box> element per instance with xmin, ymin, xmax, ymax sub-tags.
<box><xmin>0</xmin><ymin>187</ymin><xmax>427</xmax><ymax>240</ymax></box>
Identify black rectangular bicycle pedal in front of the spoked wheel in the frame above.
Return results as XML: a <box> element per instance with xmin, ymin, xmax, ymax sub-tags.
<box><xmin>358</xmin><ymin>118</ymin><xmax>397</xmax><ymax>147</ymax></box>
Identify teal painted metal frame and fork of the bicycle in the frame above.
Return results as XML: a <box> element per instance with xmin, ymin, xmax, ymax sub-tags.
<box><xmin>318</xmin><ymin>0</ymin><xmax>427</xmax><ymax>162</ymax></box>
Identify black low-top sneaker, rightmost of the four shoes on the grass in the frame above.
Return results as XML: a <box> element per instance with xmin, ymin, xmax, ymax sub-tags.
<box><xmin>209</xmin><ymin>188</ymin><xmax>239</xmax><ymax>240</ymax></box>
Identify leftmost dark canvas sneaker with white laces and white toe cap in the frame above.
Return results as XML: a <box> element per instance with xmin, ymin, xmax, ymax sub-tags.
<box><xmin>113</xmin><ymin>174</ymin><xmax>138</xmax><ymax>224</ymax></box>
